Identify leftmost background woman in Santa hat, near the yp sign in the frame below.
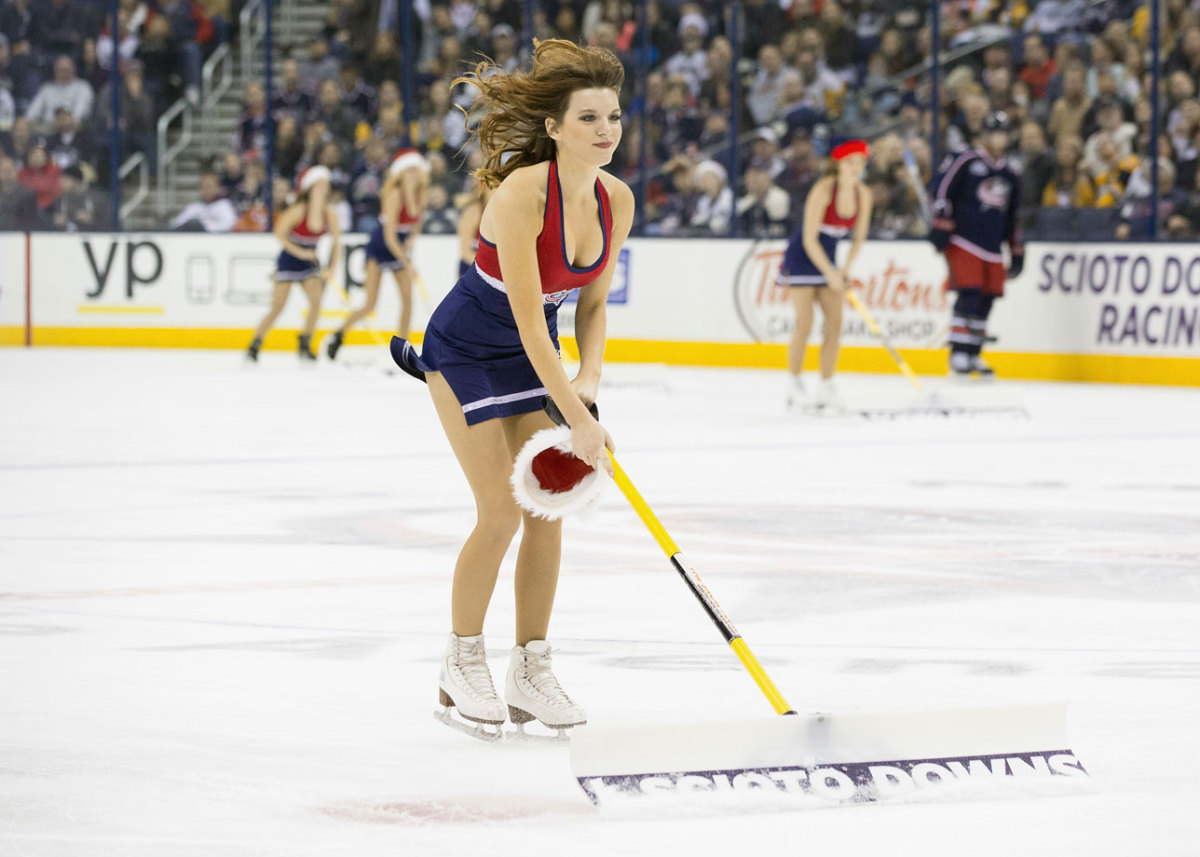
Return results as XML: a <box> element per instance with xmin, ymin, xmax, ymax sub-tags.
<box><xmin>246</xmin><ymin>166</ymin><xmax>341</xmax><ymax>361</ymax></box>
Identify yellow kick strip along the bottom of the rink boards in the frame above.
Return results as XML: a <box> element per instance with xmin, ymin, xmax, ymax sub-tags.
<box><xmin>0</xmin><ymin>326</ymin><xmax>1200</xmax><ymax>386</ymax></box>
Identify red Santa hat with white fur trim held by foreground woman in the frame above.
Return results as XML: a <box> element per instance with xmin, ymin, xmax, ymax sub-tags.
<box><xmin>511</xmin><ymin>426</ymin><xmax>611</xmax><ymax>521</ymax></box>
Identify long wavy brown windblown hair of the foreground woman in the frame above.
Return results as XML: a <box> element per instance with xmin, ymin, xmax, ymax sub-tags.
<box><xmin>455</xmin><ymin>38</ymin><xmax>625</xmax><ymax>187</ymax></box>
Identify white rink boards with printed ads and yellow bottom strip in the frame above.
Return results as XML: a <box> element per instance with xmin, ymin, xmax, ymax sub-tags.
<box><xmin>0</xmin><ymin>233</ymin><xmax>1200</xmax><ymax>385</ymax></box>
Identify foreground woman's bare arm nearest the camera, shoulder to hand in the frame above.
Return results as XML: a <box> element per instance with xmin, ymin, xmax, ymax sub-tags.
<box><xmin>488</xmin><ymin>164</ymin><xmax>612</xmax><ymax>473</ymax></box>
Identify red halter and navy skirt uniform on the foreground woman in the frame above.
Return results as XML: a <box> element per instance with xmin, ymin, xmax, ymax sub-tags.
<box><xmin>408</xmin><ymin>161</ymin><xmax>612</xmax><ymax>425</ymax></box>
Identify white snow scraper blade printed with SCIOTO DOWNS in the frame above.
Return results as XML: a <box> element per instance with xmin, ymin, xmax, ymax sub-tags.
<box><xmin>570</xmin><ymin>703</ymin><xmax>1087</xmax><ymax>804</ymax></box>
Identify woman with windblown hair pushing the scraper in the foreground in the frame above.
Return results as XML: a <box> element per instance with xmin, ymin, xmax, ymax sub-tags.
<box><xmin>396</xmin><ymin>40</ymin><xmax>634</xmax><ymax>727</ymax></box>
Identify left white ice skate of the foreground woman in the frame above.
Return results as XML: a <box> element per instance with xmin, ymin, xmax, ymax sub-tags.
<box><xmin>433</xmin><ymin>634</ymin><xmax>505</xmax><ymax>741</ymax></box>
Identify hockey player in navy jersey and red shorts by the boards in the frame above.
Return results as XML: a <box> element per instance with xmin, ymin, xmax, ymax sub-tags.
<box><xmin>929</xmin><ymin>113</ymin><xmax>1025</xmax><ymax>378</ymax></box>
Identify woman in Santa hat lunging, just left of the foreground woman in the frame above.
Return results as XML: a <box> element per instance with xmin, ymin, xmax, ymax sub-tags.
<box><xmin>325</xmin><ymin>149</ymin><xmax>430</xmax><ymax>360</ymax></box>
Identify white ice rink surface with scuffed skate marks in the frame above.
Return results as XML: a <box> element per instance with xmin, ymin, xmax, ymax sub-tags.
<box><xmin>0</xmin><ymin>349</ymin><xmax>1200</xmax><ymax>857</ymax></box>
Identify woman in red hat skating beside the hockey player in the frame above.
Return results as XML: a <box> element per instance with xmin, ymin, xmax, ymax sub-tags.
<box><xmin>779</xmin><ymin>140</ymin><xmax>871</xmax><ymax>410</ymax></box>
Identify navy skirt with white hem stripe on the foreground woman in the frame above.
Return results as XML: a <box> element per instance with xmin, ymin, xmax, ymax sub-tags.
<box><xmin>416</xmin><ymin>265</ymin><xmax>558</xmax><ymax>425</ymax></box>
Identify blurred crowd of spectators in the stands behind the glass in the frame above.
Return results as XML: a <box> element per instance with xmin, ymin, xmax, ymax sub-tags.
<box><xmin>7</xmin><ymin>0</ymin><xmax>1200</xmax><ymax>238</ymax></box>
